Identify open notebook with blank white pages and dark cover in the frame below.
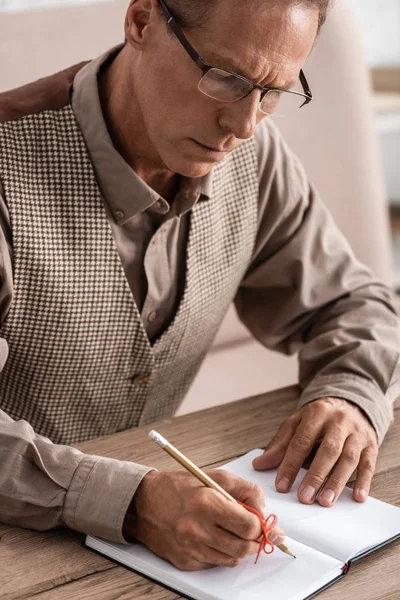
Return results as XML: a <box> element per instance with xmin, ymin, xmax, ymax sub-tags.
<box><xmin>85</xmin><ymin>450</ymin><xmax>400</xmax><ymax>600</ymax></box>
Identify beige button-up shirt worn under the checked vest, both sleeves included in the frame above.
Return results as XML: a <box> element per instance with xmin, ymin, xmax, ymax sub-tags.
<box><xmin>0</xmin><ymin>48</ymin><xmax>400</xmax><ymax>542</ymax></box>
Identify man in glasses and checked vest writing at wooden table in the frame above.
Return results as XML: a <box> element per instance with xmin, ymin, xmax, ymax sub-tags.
<box><xmin>0</xmin><ymin>0</ymin><xmax>399</xmax><ymax>569</ymax></box>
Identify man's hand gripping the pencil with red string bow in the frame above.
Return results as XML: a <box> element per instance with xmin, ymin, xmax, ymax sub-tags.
<box><xmin>124</xmin><ymin>469</ymin><xmax>284</xmax><ymax>571</ymax></box>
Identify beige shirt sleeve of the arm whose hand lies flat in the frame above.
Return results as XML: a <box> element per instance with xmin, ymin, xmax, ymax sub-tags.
<box><xmin>235</xmin><ymin>121</ymin><xmax>400</xmax><ymax>443</ymax></box>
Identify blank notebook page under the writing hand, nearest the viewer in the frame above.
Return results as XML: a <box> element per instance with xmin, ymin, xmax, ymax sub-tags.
<box><xmin>91</xmin><ymin>538</ymin><xmax>343</xmax><ymax>600</ymax></box>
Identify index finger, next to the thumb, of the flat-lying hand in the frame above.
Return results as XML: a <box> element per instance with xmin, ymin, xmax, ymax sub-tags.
<box><xmin>276</xmin><ymin>419</ymin><xmax>321</xmax><ymax>492</ymax></box>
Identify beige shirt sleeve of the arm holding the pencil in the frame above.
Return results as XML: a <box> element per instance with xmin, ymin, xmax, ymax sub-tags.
<box><xmin>0</xmin><ymin>182</ymin><xmax>151</xmax><ymax>543</ymax></box>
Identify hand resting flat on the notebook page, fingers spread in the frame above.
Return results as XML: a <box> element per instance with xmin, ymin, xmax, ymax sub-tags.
<box><xmin>253</xmin><ymin>398</ymin><xmax>378</xmax><ymax>507</ymax></box>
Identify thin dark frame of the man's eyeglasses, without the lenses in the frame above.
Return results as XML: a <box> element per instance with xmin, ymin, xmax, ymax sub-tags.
<box><xmin>159</xmin><ymin>0</ymin><xmax>313</xmax><ymax>114</ymax></box>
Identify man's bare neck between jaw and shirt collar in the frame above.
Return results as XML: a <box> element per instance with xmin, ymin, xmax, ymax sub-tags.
<box><xmin>98</xmin><ymin>49</ymin><xmax>178</xmax><ymax>200</ymax></box>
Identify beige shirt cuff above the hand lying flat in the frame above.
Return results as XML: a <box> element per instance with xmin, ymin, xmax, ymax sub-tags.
<box><xmin>298</xmin><ymin>375</ymin><xmax>394</xmax><ymax>446</ymax></box>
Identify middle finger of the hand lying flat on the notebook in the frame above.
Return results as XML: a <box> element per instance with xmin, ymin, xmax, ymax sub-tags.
<box><xmin>297</xmin><ymin>428</ymin><xmax>346</xmax><ymax>504</ymax></box>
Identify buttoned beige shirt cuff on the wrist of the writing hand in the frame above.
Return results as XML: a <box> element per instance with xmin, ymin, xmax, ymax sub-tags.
<box><xmin>63</xmin><ymin>455</ymin><xmax>153</xmax><ymax>544</ymax></box>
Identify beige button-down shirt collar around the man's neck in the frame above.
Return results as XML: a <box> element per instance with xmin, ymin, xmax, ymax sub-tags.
<box><xmin>71</xmin><ymin>45</ymin><xmax>212</xmax><ymax>225</ymax></box>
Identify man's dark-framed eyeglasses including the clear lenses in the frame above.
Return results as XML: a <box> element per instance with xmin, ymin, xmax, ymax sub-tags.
<box><xmin>159</xmin><ymin>0</ymin><xmax>313</xmax><ymax>115</ymax></box>
